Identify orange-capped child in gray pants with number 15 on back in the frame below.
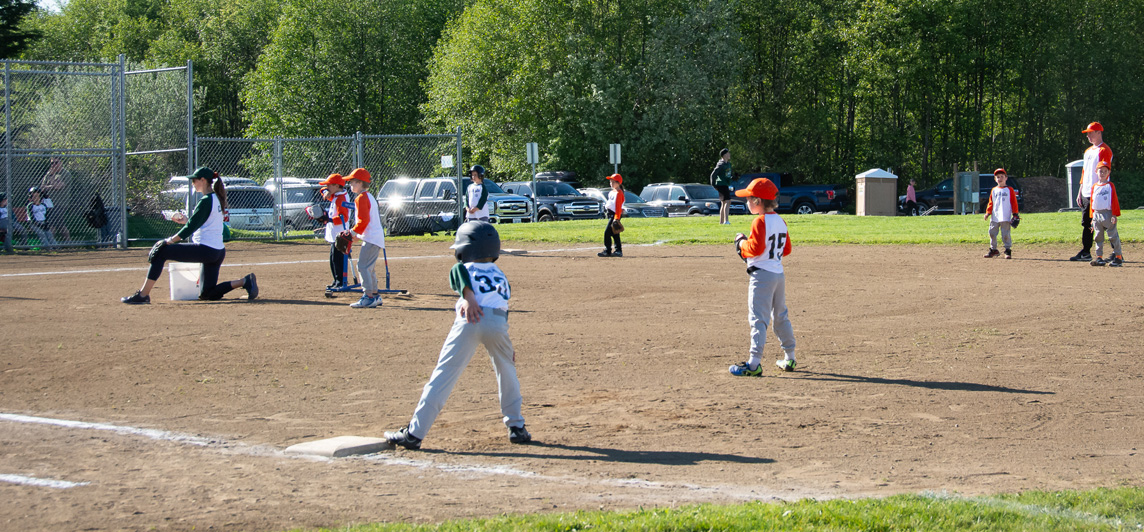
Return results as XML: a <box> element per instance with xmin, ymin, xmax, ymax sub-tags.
<box><xmin>730</xmin><ymin>177</ymin><xmax>795</xmax><ymax>376</ymax></box>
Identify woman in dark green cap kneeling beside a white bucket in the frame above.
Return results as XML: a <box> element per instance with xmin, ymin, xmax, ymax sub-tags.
<box><xmin>120</xmin><ymin>167</ymin><xmax>259</xmax><ymax>304</ymax></box>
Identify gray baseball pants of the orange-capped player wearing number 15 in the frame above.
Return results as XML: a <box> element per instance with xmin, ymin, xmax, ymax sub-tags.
<box><xmin>747</xmin><ymin>270</ymin><xmax>794</xmax><ymax>366</ymax></box>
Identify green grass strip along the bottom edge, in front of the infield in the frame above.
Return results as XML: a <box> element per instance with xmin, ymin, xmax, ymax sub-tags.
<box><xmin>304</xmin><ymin>487</ymin><xmax>1144</xmax><ymax>532</ymax></box>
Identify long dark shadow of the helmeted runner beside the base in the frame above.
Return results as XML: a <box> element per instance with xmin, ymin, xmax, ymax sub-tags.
<box><xmin>441</xmin><ymin>440</ymin><xmax>774</xmax><ymax>466</ymax></box>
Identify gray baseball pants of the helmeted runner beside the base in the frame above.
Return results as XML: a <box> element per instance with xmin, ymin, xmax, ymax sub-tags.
<box><xmin>410</xmin><ymin>307</ymin><xmax>524</xmax><ymax>438</ymax></box>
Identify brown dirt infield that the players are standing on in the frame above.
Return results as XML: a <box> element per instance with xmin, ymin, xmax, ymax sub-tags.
<box><xmin>0</xmin><ymin>243</ymin><xmax>1144</xmax><ymax>530</ymax></box>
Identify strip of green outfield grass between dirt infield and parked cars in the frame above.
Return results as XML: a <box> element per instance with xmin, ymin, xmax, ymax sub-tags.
<box><xmin>379</xmin><ymin>209</ymin><xmax>1144</xmax><ymax>245</ymax></box>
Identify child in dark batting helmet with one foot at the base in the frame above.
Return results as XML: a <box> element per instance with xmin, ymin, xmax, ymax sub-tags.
<box><xmin>386</xmin><ymin>222</ymin><xmax>532</xmax><ymax>448</ymax></box>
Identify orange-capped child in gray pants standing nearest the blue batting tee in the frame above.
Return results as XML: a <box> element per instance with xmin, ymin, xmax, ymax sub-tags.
<box><xmin>345</xmin><ymin>168</ymin><xmax>386</xmax><ymax>309</ymax></box>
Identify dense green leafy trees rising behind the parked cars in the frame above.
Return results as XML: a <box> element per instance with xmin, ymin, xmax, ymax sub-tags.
<box><xmin>8</xmin><ymin>0</ymin><xmax>1144</xmax><ymax>195</ymax></box>
